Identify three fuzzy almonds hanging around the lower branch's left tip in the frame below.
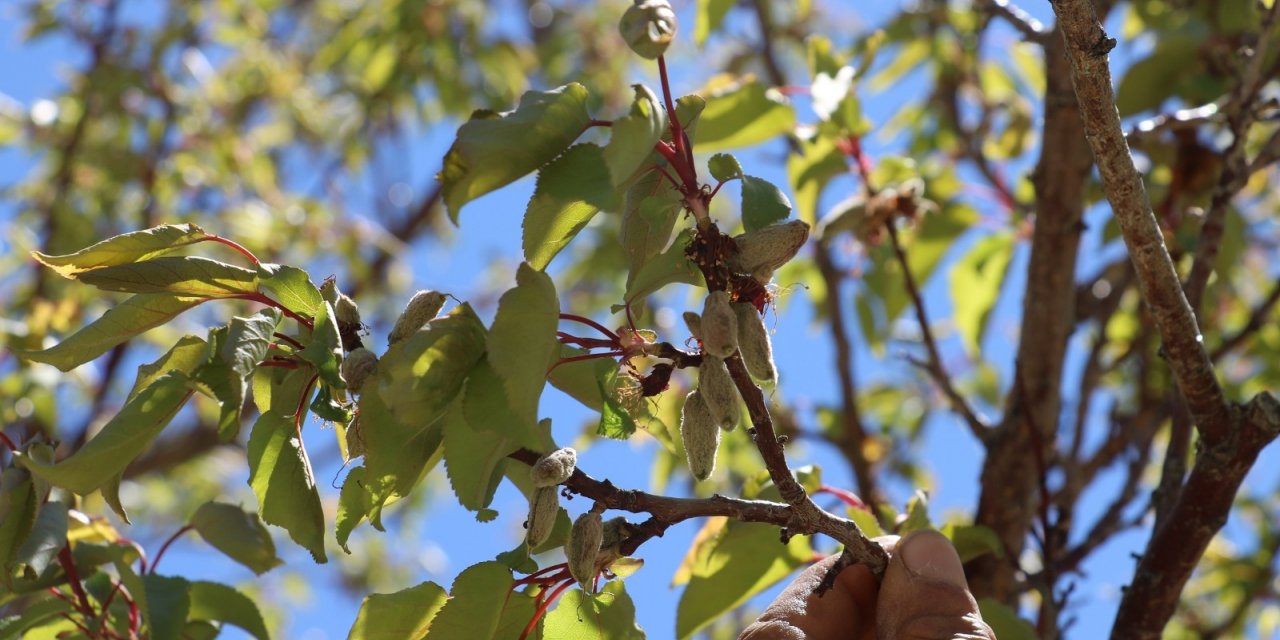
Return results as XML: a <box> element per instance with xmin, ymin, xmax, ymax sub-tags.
<box><xmin>525</xmin><ymin>447</ymin><xmax>634</xmax><ymax>593</ymax></box>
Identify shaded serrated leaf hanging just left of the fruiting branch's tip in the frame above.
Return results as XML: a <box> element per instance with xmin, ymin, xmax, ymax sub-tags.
<box><xmin>444</xmin><ymin>403</ymin><xmax>516</xmax><ymax>511</ymax></box>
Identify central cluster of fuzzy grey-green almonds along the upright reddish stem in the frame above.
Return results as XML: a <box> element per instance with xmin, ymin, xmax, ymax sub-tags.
<box><xmin>680</xmin><ymin>220</ymin><xmax>809</xmax><ymax>480</ymax></box>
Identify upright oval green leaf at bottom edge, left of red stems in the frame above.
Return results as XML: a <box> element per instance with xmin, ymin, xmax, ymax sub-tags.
<box><xmin>426</xmin><ymin>562</ymin><xmax>512</xmax><ymax>640</ymax></box>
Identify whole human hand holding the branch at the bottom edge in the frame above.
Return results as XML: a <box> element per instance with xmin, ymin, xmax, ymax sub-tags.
<box><xmin>739</xmin><ymin>530</ymin><xmax>996</xmax><ymax>640</ymax></box>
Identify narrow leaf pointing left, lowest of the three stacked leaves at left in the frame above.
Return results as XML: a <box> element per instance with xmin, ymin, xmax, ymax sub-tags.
<box><xmin>19</xmin><ymin>293</ymin><xmax>205</xmax><ymax>371</ymax></box>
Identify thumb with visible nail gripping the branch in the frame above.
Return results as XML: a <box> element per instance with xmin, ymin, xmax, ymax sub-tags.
<box><xmin>876</xmin><ymin>530</ymin><xmax>996</xmax><ymax>640</ymax></box>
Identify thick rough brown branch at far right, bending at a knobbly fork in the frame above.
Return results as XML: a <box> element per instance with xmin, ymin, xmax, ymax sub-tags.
<box><xmin>1053</xmin><ymin>0</ymin><xmax>1280</xmax><ymax>639</ymax></box>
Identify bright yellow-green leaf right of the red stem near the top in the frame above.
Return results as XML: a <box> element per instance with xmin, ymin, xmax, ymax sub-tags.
<box><xmin>694</xmin><ymin>79</ymin><xmax>796</xmax><ymax>152</ymax></box>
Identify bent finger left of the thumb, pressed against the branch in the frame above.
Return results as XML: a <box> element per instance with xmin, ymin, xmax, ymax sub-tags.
<box><xmin>739</xmin><ymin>554</ymin><xmax>876</xmax><ymax>640</ymax></box>
